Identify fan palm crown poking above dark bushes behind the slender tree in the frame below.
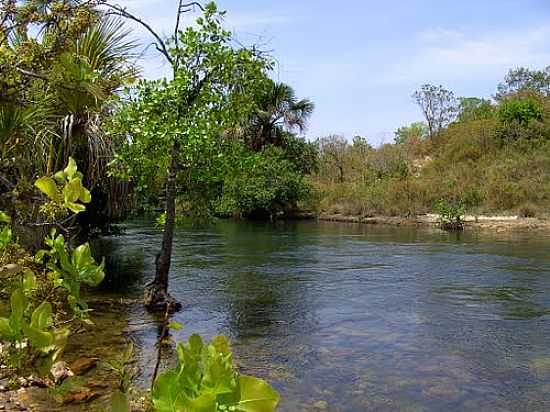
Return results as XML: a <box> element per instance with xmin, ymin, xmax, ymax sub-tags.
<box><xmin>246</xmin><ymin>81</ymin><xmax>314</xmax><ymax>151</ymax></box>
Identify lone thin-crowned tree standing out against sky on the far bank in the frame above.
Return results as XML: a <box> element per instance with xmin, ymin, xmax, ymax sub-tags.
<box><xmin>413</xmin><ymin>84</ymin><xmax>457</xmax><ymax>140</ymax></box>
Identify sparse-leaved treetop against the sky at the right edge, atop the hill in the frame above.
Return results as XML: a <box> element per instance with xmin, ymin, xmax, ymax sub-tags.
<box><xmin>496</xmin><ymin>66</ymin><xmax>550</xmax><ymax>100</ymax></box>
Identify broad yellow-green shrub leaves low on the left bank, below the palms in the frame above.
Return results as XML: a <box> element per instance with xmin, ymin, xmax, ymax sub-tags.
<box><xmin>0</xmin><ymin>159</ymin><xmax>104</xmax><ymax>382</ymax></box>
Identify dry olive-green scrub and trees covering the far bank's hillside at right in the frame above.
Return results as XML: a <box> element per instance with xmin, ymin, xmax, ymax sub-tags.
<box><xmin>313</xmin><ymin>68</ymin><xmax>550</xmax><ymax>217</ymax></box>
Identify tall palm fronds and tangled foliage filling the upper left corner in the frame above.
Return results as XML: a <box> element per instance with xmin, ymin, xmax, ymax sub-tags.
<box><xmin>0</xmin><ymin>0</ymin><xmax>137</xmax><ymax>230</ymax></box>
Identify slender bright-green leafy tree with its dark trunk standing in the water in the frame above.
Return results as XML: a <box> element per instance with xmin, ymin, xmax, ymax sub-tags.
<box><xmin>112</xmin><ymin>3</ymin><xmax>267</xmax><ymax>309</ymax></box>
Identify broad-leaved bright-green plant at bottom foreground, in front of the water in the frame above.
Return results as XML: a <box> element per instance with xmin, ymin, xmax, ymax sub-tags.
<box><xmin>152</xmin><ymin>335</ymin><xmax>279</xmax><ymax>412</ymax></box>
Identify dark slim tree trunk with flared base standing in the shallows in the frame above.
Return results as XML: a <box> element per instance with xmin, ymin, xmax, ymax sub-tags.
<box><xmin>144</xmin><ymin>143</ymin><xmax>181</xmax><ymax>311</ymax></box>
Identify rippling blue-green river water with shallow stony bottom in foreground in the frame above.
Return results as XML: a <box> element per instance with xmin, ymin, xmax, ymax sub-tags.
<box><xmin>96</xmin><ymin>221</ymin><xmax>550</xmax><ymax>412</ymax></box>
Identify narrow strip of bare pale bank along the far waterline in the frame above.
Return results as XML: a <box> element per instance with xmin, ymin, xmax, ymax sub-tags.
<box><xmin>318</xmin><ymin>213</ymin><xmax>550</xmax><ymax>232</ymax></box>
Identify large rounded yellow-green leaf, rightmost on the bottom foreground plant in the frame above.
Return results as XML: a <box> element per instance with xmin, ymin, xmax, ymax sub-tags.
<box><xmin>235</xmin><ymin>375</ymin><xmax>279</xmax><ymax>412</ymax></box>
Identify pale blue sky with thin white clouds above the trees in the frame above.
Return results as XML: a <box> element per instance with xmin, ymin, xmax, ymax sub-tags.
<box><xmin>114</xmin><ymin>0</ymin><xmax>550</xmax><ymax>145</ymax></box>
